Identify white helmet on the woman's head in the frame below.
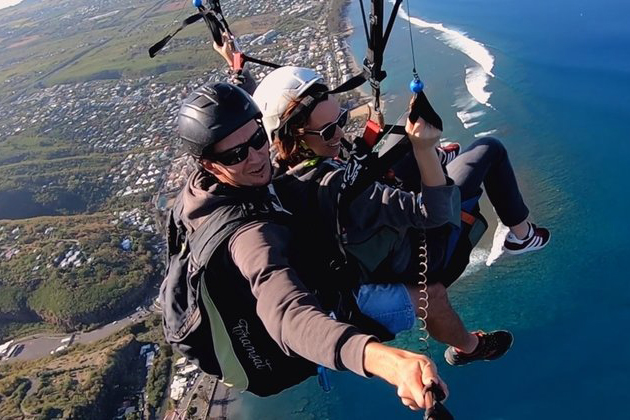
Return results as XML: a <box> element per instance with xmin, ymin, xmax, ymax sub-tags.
<box><xmin>254</xmin><ymin>66</ymin><xmax>324</xmax><ymax>141</ymax></box>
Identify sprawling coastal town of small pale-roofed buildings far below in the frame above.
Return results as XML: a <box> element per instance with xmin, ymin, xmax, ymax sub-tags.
<box><xmin>0</xmin><ymin>0</ymin><xmax>365</xmax><ymax>419</ymax></box>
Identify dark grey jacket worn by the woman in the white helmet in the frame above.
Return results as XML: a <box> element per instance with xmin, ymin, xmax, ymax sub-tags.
<box><xmin>274</xmin><ymin>158</ymin><xmax>461</xmax><ymax>281</ymax></box>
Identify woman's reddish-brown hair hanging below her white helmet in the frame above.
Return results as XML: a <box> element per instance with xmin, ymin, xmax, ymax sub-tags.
<box><xmin>273</xmin><ymin>83</ymin><xmax>328</xmax><ymax>167</ymax></box>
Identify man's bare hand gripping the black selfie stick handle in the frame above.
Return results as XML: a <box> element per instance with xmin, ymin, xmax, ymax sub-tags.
<box><xmin>363</xmin><ymin>342</ymin><xmax>448</xmax><ymax>410</ymax></box>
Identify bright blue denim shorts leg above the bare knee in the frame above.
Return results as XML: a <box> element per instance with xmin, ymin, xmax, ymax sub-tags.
<box><xmin>356</xmin><ymin>283</ymin><xmax>416</xmax><ymax>334</ymax></box>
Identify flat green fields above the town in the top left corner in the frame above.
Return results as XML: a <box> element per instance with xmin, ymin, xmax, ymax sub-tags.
<box><xmin>0</xmin><ymin>0</ymin><xmax>230</xmax><ymax>98</ymax></box>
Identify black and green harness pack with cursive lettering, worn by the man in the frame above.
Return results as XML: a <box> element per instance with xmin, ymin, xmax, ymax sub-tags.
<box><xmin>160</xmin><ymin>182</ymin><xmax>393</xmax><ymax>396</ymax></box>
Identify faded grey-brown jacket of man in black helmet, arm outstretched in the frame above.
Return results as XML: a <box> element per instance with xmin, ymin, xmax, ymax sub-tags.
<box><xmin>182</xmin><ymin>171</ymin><xmax>376</xmax><ymax>376</ymax></box>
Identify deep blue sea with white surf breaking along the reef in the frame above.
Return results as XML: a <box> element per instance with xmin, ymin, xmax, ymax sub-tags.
<box><xmin>238</xmin><ymin>0</ymin><xmax>630</xmax><ymax>420</ymax></box>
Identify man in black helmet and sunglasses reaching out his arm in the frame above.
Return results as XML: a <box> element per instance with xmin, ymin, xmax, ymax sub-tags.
<box><xmin>161</xmin><ymin>83</ymin><xmax>446</xmax><ymax>409</ymax></box>
